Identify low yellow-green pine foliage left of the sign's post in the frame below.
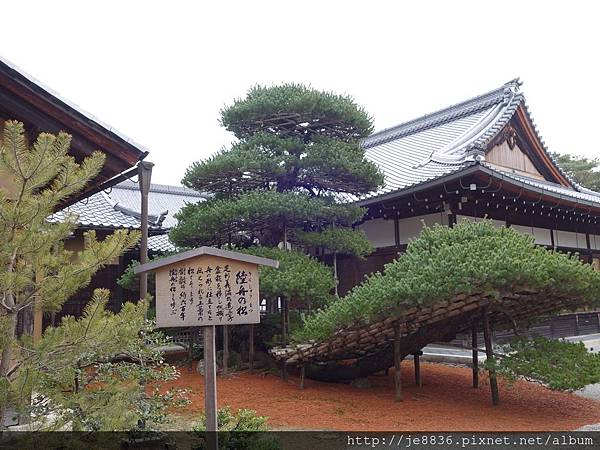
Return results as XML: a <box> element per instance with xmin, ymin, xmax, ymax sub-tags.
<box><xmin>12</xmin><ymin>290</ymin><xmax>185</xmax><ymax>431</ymax></box>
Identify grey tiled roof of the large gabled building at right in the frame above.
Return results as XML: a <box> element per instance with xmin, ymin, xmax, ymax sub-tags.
<box><xmin>354</xmin><ymin>79</ymin><xmax>600</xmax><ymax>207</ymax></box>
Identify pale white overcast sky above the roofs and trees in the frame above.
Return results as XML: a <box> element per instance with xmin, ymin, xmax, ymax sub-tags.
<box><xmin>0</xmin><ymin>0</ymin><xmax>600</xmax><ymax>184</ymax></box>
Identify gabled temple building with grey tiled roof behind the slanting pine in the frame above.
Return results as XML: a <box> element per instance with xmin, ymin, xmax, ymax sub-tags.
<box><xmin>337</xmin><ymin>80</ymin><xmax>600</xmax><ymax>295</ymax></box>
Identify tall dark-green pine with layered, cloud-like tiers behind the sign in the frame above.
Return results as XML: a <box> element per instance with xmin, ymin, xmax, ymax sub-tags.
<box><xmin>170</xmin><ymin>84</ymin><xmax>383</xmax><ymax>298</ymax></box>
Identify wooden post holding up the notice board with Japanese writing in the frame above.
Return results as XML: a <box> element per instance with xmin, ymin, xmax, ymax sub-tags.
<box><xmin>203</xmin><ymin>325</ymin><xmax>218</xmax><ymax>450</ymax></box>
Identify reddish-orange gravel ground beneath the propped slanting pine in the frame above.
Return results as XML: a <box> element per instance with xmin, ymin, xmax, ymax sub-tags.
<box><xmin>164</xmin><ymin>361</ymin><xmax>600</xmax><ymax>431</ymax></box>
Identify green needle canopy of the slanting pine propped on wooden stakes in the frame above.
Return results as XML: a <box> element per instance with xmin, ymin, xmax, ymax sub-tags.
<box><xmin>293</xmin><ymin>221</ymin><xmax>600</xmax><ymax>342</ymax></box>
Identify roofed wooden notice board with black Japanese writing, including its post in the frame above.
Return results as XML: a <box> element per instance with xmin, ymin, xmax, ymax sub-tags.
<box><xmin>134</xmin><ymin>247</ymin><xmax>279</xmax><ymax>449</ymax></box>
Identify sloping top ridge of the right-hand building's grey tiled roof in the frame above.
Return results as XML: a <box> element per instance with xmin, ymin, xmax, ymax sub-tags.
<box><xmin>362</xmin><ymin>78</ymin><xmax>522</xmax><ymax>148</ymax></box>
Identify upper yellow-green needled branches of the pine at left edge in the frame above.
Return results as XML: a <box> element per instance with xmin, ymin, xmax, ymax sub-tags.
<box><xmin>0</xmin><ymin>121</ymin><xmax>139</xmax><ymax>428</ymax></box>
